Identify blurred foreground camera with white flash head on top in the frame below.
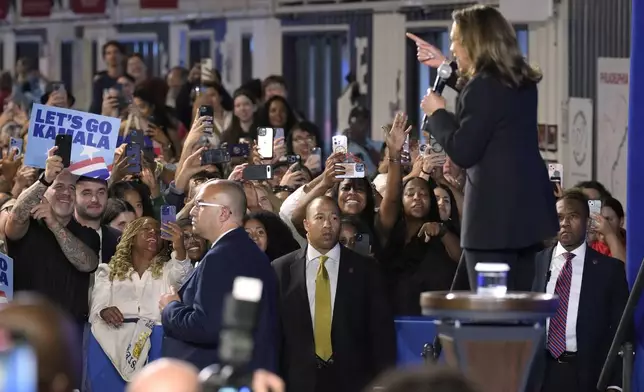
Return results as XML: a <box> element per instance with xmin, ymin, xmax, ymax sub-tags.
<box><xmin>199</xmin><ymin>276</ymin><xmax>263</xmax><ymax>392</ymax></box>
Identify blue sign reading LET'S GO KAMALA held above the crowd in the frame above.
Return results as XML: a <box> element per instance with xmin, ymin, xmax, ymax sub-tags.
<box><xmin>25</xmin><ymin>104</ymin><xmax>121</xmax><ymax>179</ymax></box>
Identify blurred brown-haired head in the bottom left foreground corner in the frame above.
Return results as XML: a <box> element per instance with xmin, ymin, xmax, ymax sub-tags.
<box><xmin>0</xmin><ymin>293</ymin><xmax>81</xmax><ymax>392</ymax></box>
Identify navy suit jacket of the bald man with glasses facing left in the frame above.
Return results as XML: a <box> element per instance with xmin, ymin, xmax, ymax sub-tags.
<box><xmin>161</xmin><ymin>228</ymin><xmax>277</xmax><ymax>372</ymax></box>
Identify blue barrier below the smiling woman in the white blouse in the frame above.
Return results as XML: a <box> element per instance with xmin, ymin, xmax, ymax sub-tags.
<box><xmin>83</xmin><ymin>324</ymin><xmax>163</xmax><ymax>392</ymax></box>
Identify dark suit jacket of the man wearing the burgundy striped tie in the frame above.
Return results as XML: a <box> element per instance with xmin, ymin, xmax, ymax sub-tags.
<box><xmin>532</xmin><ymin>246</ymin><xmax>628</xmax><ymax>391</ymax></box>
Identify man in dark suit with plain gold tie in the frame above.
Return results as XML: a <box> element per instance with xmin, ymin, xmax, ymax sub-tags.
<box><xmin>273</xmin><ymin>196</ymin><xmax>396</xmax><ymax>392</ymax></box>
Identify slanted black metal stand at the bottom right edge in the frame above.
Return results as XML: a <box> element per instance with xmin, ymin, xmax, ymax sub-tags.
<box><xmin>597</xmin><ymin>260</ymin><xmax>644</xmax><ymax>392</ymax></box>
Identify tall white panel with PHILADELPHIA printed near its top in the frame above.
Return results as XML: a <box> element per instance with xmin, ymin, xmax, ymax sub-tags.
<box><xmin>596</xmin><ymin>58</ymin><xmax>630</xmax><ymax>206</ymax></box>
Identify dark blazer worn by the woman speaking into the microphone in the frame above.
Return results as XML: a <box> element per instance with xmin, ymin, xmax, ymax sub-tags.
<box><xmin>428</xmin><ymin>74</ymin><xmax>559</xmax><ymax>250</ymax></box>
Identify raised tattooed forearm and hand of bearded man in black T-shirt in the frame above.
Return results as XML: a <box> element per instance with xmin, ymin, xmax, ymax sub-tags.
<box><xmin>5</xmin><ymin>147</ymin><xmax>63</xmax><ymax>241</ymax></box>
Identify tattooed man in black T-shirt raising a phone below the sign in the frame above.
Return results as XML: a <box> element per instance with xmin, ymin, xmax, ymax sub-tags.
<box><xmin>5</xmin><ymin>147</ymin><xmax>100</xmax><ymax>330</ymax></box>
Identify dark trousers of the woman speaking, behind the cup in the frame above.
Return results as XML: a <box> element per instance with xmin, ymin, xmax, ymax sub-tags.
<box><xmin>452</xmin><ymin>245</ymin><xmax>543</xmax><ymax>291</ymax></box>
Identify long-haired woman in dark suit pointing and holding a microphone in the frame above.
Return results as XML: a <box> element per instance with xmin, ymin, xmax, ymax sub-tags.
<box><xmin>408</xmin><ymin>6</ymin><xmax>559</xmax><ymax>290</ymax></box>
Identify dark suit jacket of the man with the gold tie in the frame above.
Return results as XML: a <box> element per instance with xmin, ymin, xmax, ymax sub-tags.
<box><xmin>272</xmin><ymin>247</ymin><xmax>396</xmax><ymax>392</ymax></box>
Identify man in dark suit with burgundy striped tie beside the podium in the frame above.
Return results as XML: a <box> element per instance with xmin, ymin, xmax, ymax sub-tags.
<box><xmin>532</xmin><ymin>190</ymin><xmax>628</xmax><ymax>392</ymax></box>
